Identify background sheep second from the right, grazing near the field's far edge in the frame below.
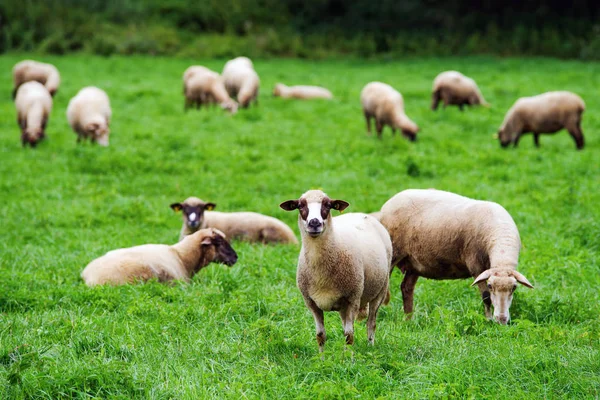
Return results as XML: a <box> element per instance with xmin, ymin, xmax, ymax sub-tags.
<box><xmin>431</xmin><ymin>71</ymin><xmax>490</xmax><ymax>111</ymax></box>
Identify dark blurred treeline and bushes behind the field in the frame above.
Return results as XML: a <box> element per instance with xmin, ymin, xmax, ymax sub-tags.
<box><xmin>0</xmin><ymin>0</ymin><xmax>600</xmax><ymax>59</ymax></box>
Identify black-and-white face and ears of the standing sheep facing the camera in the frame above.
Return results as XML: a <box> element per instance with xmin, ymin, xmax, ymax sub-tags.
<box><xmin>279</xmin><ymin>190</ymin><xmax>349</xmax><ymax>238</ymax></box>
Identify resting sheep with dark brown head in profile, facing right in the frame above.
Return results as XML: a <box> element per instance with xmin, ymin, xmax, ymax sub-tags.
<box><xmin>81</xmin><ymin>229</ymin><xmax>237</xmax><ymax>286</ymax></box>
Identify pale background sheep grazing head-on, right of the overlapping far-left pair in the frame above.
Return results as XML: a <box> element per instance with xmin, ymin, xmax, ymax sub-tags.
<box><xmin>67</xmin><ymin>86</ymin><xmax>112</xmax><ymax>146</ymax></box>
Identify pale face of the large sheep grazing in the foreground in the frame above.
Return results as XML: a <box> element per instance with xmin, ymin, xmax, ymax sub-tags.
<box><xmin>473</xmin><ymin>268</ymin><xmax>533</xmax><ymax>325</ymax></box>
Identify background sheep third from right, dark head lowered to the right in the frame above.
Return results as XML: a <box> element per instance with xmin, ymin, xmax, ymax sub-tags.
<box><xmin>360</xmin><ymin>82</ymin><xmax>419</xmax><ymax>141</ymax></box>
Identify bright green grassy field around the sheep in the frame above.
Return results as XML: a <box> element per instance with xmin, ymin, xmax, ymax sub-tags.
<box><xmin>0</xmin><ymin>54</ymin><xmax>600</xmax><ymax>399</ymax></box>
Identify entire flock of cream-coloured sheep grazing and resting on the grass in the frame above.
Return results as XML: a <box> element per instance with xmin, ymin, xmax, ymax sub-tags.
<box><xmin>13</xmin><ymin>57</ymin><xmax>585</xmax><ymax>351</ymax></box>
